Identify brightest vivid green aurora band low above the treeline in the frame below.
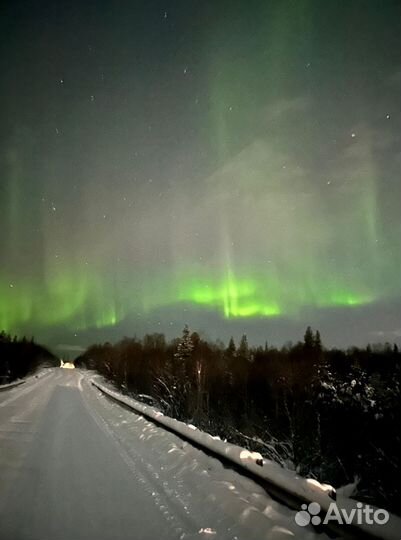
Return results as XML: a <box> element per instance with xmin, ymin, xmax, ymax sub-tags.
<box><xmin>0</xmin><ymin>256</ymin><xmax>384</xmax><ymax>330</ymax></box>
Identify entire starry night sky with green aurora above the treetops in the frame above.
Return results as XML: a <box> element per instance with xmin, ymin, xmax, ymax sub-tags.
<box><xmin>0</xmin><ymin>0</ymin><xmax>401</xmax><ymax>350</ymax></box>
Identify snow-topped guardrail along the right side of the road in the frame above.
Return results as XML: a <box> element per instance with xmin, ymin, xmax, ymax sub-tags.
<box><xmin>91</xmin><ymin>379</ymin><xmax>401</xmax><ymax>540</ymax></box>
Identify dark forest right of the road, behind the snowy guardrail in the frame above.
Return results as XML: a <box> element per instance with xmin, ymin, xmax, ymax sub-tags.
<box><xmin>76</xmin><ymin>326</ymin><xmax>401</xmax><ymax>514</ymax></box>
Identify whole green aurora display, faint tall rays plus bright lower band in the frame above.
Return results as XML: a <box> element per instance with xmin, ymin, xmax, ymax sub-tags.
<box><xmin>0</xmin><ymin>1</ymin><xmax>401</xmax><ymax>346</ymax></box>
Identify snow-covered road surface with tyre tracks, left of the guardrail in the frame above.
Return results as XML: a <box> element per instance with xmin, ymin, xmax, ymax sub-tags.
<box><xmin>0</xmin><ymin>368</ymin><xmax>326</xmax><ymax>540</ymax></box>
